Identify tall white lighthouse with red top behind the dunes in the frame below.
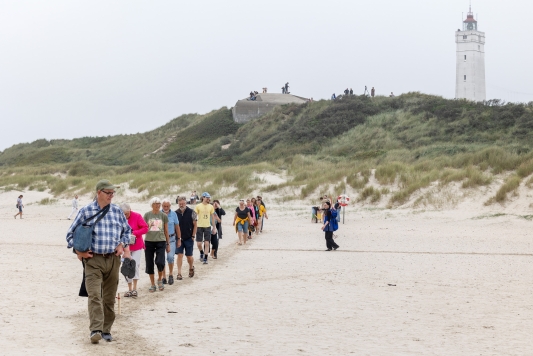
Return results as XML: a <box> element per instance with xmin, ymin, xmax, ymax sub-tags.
<box><xmin>455</xmin><ymin>6</ymin><xmax>486</xmax><ymax>101</ymax></box>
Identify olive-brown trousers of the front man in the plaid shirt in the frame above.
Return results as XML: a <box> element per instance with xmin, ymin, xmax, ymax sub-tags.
<box><xmin>84</xmin><ymin>254</ymin><xmax>120</xmax><ymax>333</ymax></box>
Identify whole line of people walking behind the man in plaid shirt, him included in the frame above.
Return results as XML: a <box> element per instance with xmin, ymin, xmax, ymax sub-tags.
<box><xmin>66</xmin><ymin>180</ymin><xmax>268</xmax><ymax>344</ymax></box>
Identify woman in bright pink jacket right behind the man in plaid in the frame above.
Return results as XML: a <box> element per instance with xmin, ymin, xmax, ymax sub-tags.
<box><xmin>120</xmin><ymin>203</ymin><xmax>148</xmax><ymax>298</ymax></box>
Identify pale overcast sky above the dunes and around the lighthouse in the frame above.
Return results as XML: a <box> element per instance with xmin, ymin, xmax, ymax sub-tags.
<box><xmin>0</xmin><ymin>0</ymin><xmax>533</xmax><ymax>150</ymax></box>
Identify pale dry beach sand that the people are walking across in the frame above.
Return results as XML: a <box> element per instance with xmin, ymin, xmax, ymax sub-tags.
<box><xmin>0</xmin><ymin>192</ymin><xmax>533</xmax><ymax>355</ymax></box>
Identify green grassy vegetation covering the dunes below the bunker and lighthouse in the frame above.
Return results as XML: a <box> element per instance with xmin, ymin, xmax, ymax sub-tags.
<box><xmin>0</xmin><ymin>93</ymin><xmax>533</xmax><ymax>208</ymax></box>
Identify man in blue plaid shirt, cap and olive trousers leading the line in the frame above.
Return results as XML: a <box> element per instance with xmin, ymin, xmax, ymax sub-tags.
<box><xmin>67</xmin><ymin>180</ymin><xmax>131</xmax><ymax>344</ymax></box>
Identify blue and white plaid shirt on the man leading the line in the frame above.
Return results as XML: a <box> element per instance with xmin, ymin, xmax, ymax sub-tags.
<box><xmin>67</xmin><ymin>201</ymin><xmax>131</xmax><ymax>254</ymax></box>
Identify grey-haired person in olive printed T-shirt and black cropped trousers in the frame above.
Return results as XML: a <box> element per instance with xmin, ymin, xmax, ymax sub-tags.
<box><xmin>144</xmin><ymin>197</ymin><xmax>170</xmax><ymax>293</ymax></box>
